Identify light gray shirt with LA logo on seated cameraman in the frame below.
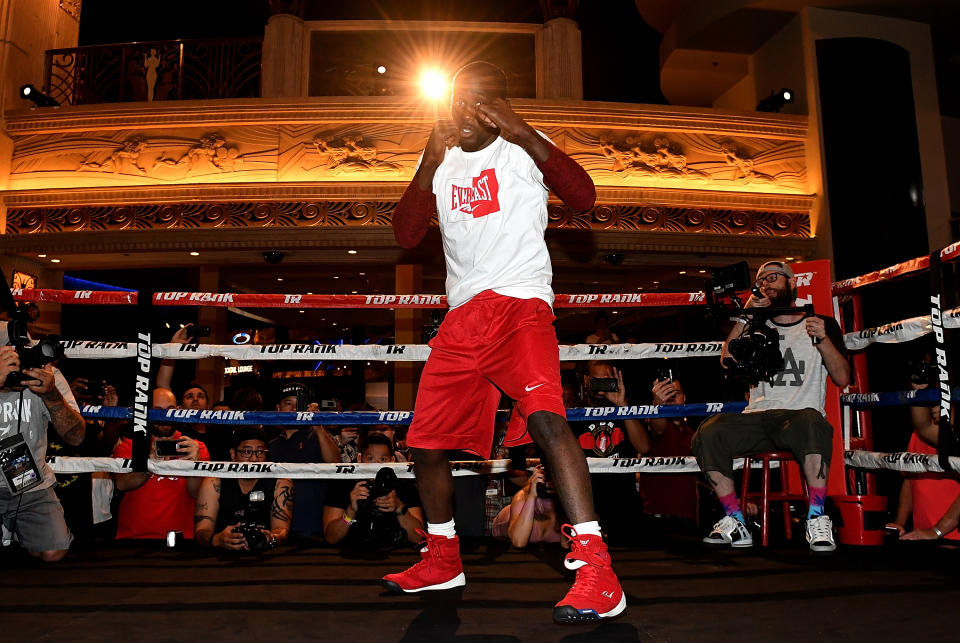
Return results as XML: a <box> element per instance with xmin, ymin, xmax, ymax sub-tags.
<box><xmin>743</xmin><ymin>317</ymin><xmax>844</xmax><ymax>415</ymax></box>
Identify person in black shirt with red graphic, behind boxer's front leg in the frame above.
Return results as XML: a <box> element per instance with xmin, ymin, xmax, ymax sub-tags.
<box><xmin>570</xmin><ymin>360</ymin><xmax>650</xmax><ymax>541</ymax></box>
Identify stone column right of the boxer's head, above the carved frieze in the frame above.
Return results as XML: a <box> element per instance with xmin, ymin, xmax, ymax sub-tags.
<box><xmin>536</xmin><ymin>18</ymin><xmax>583</xmax><ymax>100</ymax></box>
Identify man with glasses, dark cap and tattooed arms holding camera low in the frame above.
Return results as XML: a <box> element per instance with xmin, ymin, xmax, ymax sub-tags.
<box><xmin>193</xmin><ymin>427</ymin><xmax>294</xmax><ymax>552</ymax></box>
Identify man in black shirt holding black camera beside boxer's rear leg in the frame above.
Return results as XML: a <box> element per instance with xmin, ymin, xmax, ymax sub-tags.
<box><xmin>323</xmin><ymin>433</ymin><xmax>424</xmax><ymax>547</ymax></box>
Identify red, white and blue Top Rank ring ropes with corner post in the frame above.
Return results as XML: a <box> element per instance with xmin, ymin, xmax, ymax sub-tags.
<box><xmin>14</xmin><ymin>244</ymin><xmax>960</xmax><ymax>528</ymax></box>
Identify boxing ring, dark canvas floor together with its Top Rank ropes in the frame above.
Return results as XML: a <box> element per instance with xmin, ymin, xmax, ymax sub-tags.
<box><xmin>0</xmin><ymin>246</ymin><xmax>960</xmax><ymax>642</ymax></box>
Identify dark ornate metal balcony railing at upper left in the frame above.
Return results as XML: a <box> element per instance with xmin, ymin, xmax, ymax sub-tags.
<box><xmin>46</xmin><ymin>38</ymin><xmax>263</xmax><ymax>105</ymax></box>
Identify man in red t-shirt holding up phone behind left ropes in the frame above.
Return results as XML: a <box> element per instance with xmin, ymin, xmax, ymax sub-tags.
<box><xmin>113</xmin><ymin>388</ymin><xmax>210</xmax><ymax>538</ymax></box>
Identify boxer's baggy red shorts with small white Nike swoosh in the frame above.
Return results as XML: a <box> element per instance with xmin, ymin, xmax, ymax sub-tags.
<box><xmin>407</xmin><ymin>290</ymin><xmax>566</xmax><ymax>458</ymax></box>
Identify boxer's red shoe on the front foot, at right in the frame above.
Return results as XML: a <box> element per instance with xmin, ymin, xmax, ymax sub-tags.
<box><xmin>553</xmin><ymin>525</ymin><xmax>627</xmax><ymax>623</ymax></box>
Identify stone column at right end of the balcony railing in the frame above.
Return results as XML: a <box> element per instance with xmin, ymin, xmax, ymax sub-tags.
<box><xmin>260</xmin><ymin>0</ymin><xmax>309</xmax><ymax>98</ymax></box>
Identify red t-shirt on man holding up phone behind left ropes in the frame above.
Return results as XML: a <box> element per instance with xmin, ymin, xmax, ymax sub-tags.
<box><xmin>113</xmin><ymin>431</ymin><xmax>210</xmax><ymax>539</ymax></box>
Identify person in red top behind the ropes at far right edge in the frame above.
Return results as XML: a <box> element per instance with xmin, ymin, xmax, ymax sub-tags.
<box><xmin>885</xmin><ymin>374</ymin><xmax>960</xmax><ymax>541</ymax></box>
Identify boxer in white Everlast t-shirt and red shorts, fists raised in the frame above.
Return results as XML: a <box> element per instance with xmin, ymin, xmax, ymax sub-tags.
<box><xmin>384</xmin><ymin>62</ymin><xmax>626</xmax><ymax>622</ymax></box>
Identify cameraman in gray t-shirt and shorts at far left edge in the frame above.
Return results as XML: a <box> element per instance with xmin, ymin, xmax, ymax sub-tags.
<box><xmin>0</xmin><ymin>342</ymin><xmax>86</xmax><ymax>562</ymax></box>
